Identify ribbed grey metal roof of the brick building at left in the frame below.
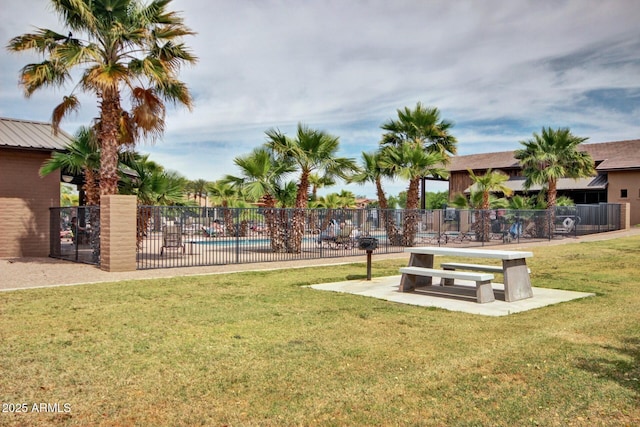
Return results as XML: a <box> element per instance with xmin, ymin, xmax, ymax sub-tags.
<box><xmin>0</xmin><ymin>117</ymin><xmax>72</xmax><ymax>151</ymax></box>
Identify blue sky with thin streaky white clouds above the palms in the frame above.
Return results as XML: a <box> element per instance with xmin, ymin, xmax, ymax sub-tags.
<box><xmin>0</xmin><ymin>0</ymin><xmax>640</xmax><ymax>197</ymax></box>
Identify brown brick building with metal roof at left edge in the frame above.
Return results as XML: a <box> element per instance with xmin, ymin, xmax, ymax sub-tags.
<box><xmin>0</xmin><ymin>118</ymin><xmax>71</xmax><ymax>257</ymax></box>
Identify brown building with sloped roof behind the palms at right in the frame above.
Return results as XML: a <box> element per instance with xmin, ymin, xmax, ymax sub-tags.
<box><xmin>448</xmin><ymin>139</ymin><xmax>640</xmax><ymax>224</ymax></box>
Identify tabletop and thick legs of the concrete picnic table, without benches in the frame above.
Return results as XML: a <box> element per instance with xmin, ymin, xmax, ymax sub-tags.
<box><xmin>400</xmin><ymin>246</ymin><xmax>533</xmax><ymax>302</ymax></box>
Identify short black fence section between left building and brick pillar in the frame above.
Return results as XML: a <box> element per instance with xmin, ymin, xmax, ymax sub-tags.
<box><xmin>49</xmin><ymin>206</ymin><xmax>100</xmax><ymax>265</ymax></box>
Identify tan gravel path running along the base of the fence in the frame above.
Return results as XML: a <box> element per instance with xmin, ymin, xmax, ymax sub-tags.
<box><xmin>0</xmin><ymin>227</ymin><xmax>640</xmax><ymax>291</ymax></box>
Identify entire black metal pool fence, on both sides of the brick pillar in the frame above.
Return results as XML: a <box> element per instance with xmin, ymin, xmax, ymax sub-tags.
<box><xmin>51</xmin><ymin>204</ymin><xmax>621</xmax><ymax>269</ymax></box>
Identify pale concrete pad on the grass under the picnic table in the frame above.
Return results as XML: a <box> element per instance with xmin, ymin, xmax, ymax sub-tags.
<box><xmin>309</xmin><ymin>275</ymin><xmax>595</xmax><ymax>316</ymax></box>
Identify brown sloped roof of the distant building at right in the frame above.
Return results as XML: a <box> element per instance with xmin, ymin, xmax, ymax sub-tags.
<box><xmin>447</xmin><ymin>139</ymin><xmax>640</xmax><ymax>171</ymax></box>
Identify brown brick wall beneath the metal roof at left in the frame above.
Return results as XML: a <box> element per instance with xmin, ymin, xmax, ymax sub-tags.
<box><xmin>0</xmin><ymin>148</ymin><xmax>60</xmax><ymax>257</ymax></box>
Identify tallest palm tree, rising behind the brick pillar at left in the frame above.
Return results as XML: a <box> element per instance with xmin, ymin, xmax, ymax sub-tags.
<box><xmin>7</xmin><ymin>0</ymin><xmax>196</xmax><ymax>201</ymax></box>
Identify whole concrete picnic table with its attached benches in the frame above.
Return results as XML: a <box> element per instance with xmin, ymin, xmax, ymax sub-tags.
<box><xmin>399</xmin><ymin>247</ymin><xmax>533</xmax><ymax>303</ymax></box>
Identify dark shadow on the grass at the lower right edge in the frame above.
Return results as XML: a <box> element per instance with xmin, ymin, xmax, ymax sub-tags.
<box><xmin>577</xmin><ymin>337</ymin><xmax>640</xmax><ymax>398</ymax></box>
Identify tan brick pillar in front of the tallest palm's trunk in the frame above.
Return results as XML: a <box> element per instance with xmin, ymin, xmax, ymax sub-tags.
<box><xmin>100</xmin><ymin>195</ymin><xmax>137</xmax><ymax>272</ymax></box>
